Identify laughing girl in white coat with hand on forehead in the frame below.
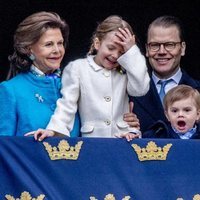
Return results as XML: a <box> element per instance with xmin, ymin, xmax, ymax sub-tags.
<box><xmin>34</xmin><ymin>16</ymin><xmax>149</xmax><ymax>141</ymax></box>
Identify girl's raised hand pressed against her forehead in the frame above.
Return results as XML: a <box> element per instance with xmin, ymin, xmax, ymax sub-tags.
<box><xmin>115</xmin><ymin>28</ymin><xmax>135</xmax><ymax>52</ymax></box>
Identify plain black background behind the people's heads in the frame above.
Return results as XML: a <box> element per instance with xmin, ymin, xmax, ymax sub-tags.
<box><xmin>0</xmin><ymin>0</ymin><xmax>200</xmax><ymax>81</ymax></box>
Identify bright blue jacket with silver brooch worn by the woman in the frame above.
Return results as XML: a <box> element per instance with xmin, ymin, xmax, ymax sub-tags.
<box><xmin>0</xmin><ymin>72</ymin><xmax>80</xmax><ymax>137</ymax></box>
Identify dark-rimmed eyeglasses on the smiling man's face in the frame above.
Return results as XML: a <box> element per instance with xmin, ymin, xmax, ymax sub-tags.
<box><xmin>147</xmin><ymin>42</ymin><xmax>181</xmax><ymax>51</ymax></box>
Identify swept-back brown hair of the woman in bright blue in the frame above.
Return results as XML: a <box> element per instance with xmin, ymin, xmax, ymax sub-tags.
<box><xmin>7</xmin><ymin>11</ymin><xmax>69</xmax><ymax>79</ymax></box>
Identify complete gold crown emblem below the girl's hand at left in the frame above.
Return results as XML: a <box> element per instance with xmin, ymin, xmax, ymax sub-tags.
<box><xmin>43</xmin><ymin>140</ymin><xmax>83</xmax><ymax>160</ymax></box>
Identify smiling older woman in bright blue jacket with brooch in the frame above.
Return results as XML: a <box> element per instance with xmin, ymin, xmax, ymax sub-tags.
<box><xmin>0</xmin><ymin>12</ymin><xmax>79</xmax><ymax>136</ymax></box>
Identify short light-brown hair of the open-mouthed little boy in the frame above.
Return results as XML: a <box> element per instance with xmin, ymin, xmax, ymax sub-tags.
<box><xmin>163</xmin><ymin>85</ymin><xmax>200</xmax><ymax>111</ymax></box>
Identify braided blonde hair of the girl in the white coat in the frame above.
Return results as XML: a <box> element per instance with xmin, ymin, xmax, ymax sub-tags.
<box><xmin>88</xmin><ymin>15</ymin><xmax>133</xmax><ymax>55</ymax></box>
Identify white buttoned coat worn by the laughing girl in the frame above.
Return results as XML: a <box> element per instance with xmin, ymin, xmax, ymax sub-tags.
<box><xmin>47</xmin><ymin>45</ymin><xmax>150</xmax><ymax>137</ymax></box>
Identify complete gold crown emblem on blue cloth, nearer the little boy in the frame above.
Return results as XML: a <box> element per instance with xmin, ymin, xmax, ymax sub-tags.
<box><xmin>131</xmin><ymin>141</ymin><xmax>172</xmax><ymax>161</ymax></box>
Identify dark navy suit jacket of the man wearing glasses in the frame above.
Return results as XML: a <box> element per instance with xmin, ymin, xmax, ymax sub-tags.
<box><xmin>130</xmin><ymin>71</ymin><xmax>200</xmax><ymax>132</ymax></box>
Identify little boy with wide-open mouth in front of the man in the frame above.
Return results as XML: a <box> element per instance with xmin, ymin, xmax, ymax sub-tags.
<box><xmin>142</xmin><ymin>85</ymin><xmax>200</xmax><ymax>139</ymax></box>
